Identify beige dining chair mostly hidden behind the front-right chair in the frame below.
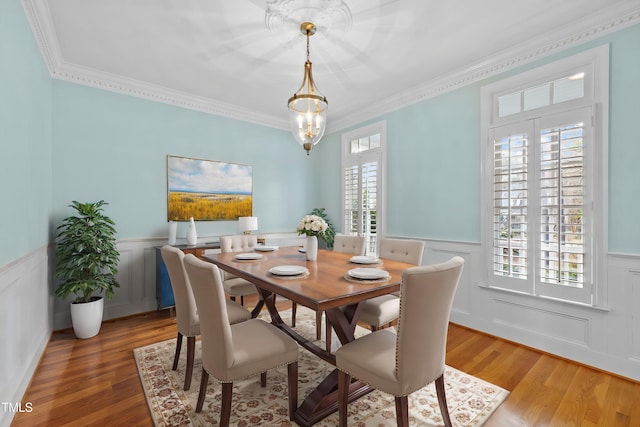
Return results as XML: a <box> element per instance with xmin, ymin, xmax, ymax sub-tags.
<box><xmin>358</xmin><ymin>238</ymin><xmax>424</xmax><ymax>331</ymax></box>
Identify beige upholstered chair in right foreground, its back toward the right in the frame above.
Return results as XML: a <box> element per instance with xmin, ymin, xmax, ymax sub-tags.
<box><xmin>336</xmin><ymin>257</ymin><xmax>464</xmax><ymax>427</ymax></box>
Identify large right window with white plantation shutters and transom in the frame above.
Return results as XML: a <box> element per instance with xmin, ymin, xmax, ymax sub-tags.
<box><xmin>482</xmin><ymin>47</ymin><xmax>608</xmax><ymax>305</ymax></box>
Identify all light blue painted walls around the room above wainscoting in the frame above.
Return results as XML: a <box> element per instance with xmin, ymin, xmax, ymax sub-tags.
<box><xmin>5</xmin><ymin>2</ymin><xmax>640</xmax><ymax>266</ymax></box>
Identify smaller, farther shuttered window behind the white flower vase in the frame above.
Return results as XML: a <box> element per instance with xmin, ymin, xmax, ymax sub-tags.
<box><xmin>342</xmin><ymin>122</ymin><xmax>386</xmax><ymax>254</ymax></box>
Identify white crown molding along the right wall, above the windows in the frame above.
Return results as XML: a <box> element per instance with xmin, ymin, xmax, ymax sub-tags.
<box><xmin>327</xmin><ymin>5</ymin><xmax>640</xmax><ymax>133</ymax></box>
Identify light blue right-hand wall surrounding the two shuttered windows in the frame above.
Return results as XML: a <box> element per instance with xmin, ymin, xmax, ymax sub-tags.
<box><xmin>312</xmin><ymin>25</ymin><xmax>640</xmax><ymax>254</ymax></box>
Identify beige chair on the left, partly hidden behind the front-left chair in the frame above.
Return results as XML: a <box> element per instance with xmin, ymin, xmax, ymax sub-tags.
<box><xmin>160</xmin><ymin>245</ymin><xmax>251</xmax><ymax>390</ymax></box>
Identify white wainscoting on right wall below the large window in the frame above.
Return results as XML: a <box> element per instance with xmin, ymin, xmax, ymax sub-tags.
<box><xmin>416</xmin><ymin>236</ymin><xmax>640</xmax><ymax>381</ymax></box>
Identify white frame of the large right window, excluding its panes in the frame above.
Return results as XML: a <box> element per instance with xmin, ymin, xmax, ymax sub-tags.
<box><xmin>479</xmin><ymin>44</ymin><xmax>609</xmax><ymax>307</ymax></box>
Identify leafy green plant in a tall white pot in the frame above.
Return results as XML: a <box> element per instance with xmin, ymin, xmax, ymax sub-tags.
<box><xmin>55</xmin><ymin>200</ymin><xmax>120</xmax><ymax>338</ymax></box>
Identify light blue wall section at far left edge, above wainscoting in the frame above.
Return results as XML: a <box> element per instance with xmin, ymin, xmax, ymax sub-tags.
<box><xmin>0</xmin><ymin>1</ymin><xmax>52</xmax><ymax>267</ymax></box>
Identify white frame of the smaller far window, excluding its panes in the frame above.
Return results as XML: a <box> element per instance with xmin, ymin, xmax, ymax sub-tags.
<box><xmin>340</xmin><ymin>121</ymin><xmax>387</xmax><ymax>253</ymax></box>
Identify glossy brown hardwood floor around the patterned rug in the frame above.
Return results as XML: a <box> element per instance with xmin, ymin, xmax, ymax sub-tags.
<box><xmin>12</xmin><ymin>300</ymin><xmax>640</xmax><ymax>427</ymax></box>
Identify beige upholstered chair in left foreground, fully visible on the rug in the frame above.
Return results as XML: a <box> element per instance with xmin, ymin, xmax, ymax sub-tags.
<box><xmin>184</xmin><ymin>254</ymin><xmax>298</xmax><ymax>427</ymax></box>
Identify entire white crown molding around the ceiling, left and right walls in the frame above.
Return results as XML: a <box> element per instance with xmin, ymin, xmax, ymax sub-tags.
<box><xmin>22</xmin><ymin>0</ymin><xmax>640</xmax><ymax>133</ymax></box>
